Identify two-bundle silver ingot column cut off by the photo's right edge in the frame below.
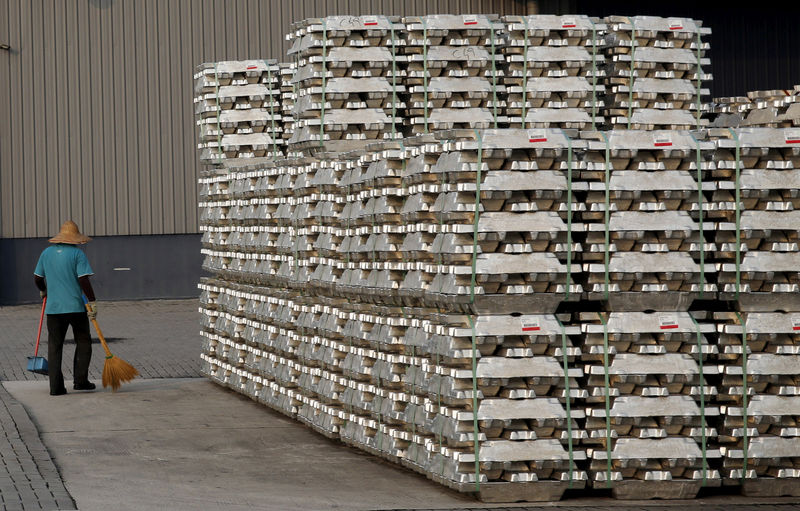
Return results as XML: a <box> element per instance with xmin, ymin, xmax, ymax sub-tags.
<box><xmin>711</xmin><ymin>128</ymin><xmax>800</xmax><ymax>495</ymax></box>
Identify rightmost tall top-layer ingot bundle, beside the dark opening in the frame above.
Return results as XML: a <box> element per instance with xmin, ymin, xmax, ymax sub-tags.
<box><xmin>605</xmin><ymin>16</ymin><xmax>711</xmax><ymax>130</ymax></box>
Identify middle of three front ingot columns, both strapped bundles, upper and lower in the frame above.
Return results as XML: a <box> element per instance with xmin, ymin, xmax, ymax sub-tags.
<box><xmin>580</xmin><ymin>130</ymin><xmax>720</xmax><ymax>498</ymax></box>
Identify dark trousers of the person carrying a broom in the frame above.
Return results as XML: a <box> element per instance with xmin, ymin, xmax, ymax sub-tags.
<box><xmin>47</xmin><ymin>312</ymin><xmax>92</xmax><ymax>393</ymax></box>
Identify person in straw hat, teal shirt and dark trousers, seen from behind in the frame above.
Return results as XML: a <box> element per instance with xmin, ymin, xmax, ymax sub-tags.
<box><xmin>33</xmin><ymin>220</ymin><xmax>97</xmax><ymax>396</ymax></box>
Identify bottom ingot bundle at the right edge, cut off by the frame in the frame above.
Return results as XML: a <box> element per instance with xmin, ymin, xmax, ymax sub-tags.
<box><xmin>715</xmin><ymin>312</ymin><xmax>800</xmax><ymax>496</ymax></box>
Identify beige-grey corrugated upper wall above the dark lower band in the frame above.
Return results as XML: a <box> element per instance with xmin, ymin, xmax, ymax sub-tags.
<box><xmin>0</xmin><ymin>0</ymin><xmax>525</xmax><ymax>238</ymax></box>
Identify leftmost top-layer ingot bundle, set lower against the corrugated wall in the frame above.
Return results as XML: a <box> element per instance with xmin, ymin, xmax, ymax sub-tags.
<box><xmin>194</xmin><ymin>60</ymin><xmax>285</xmax><ymax>164</ymax></box>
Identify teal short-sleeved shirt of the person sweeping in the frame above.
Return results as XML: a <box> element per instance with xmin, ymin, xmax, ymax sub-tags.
<box><xmin>33</xmin><ymin>243</ymin><xmax>94</xmax><ymax>314</ymax></box>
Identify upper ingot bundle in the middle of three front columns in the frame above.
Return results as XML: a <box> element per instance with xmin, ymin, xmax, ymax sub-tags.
<box><xmin>580</xmin><ymin>130</ymin><xmax>717</xmax><ymax>311</ymax></box>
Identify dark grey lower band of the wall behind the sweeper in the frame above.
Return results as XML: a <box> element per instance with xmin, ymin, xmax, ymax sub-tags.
<box><xmin>0</xmin><ymin>234</ymin><xmax>203</xmax><ymax>305</ymax></box>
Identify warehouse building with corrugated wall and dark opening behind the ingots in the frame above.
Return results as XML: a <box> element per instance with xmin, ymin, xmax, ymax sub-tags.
<box><xmin>0</xmin><ymin>0</ymin><xmax>800</xmax><ymax>305</ymax></box>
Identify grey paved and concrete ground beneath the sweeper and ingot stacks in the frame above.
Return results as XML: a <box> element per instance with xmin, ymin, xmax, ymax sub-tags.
<box><xmin>0</xmin><ymin>300</ymin><xmax>800</xmax><ymax>511</ymax></box>
